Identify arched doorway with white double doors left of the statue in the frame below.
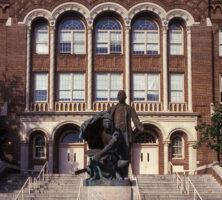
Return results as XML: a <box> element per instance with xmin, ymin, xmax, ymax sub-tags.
<box><xmin>59</xmin><ymin>130</ymin><xmax>84</xmax><ymax>174</ymax></box>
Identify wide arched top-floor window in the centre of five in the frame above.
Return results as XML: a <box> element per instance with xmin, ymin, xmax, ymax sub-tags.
<box><xmin>96</xmin><ymin>17</ymin><xmax>122</xmax><ymax>54</ymax></box>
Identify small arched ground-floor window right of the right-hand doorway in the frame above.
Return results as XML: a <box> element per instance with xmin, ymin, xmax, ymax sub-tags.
<box><xmin>171</xmin><ymin>136</ymin><xmax>183</xmax><ymax>158</ymax></box>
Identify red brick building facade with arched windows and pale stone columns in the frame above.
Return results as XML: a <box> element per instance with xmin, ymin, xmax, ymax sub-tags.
<box><xmin>0</xmin><ymin>0</ymin><xmax>222</xmax><ymax>174</ymax></box>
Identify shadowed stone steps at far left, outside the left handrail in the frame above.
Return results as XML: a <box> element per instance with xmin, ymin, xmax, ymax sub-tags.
<box><xmin>0</xmin><ymin>174</ymin><xmax>28</xmax><ymax>200</ymax></box>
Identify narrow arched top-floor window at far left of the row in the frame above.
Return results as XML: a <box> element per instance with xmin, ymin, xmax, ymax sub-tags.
<box><xmin>35</xmin><ymin>24</ymin><xmax>49</xmax><ymax>54</ymax></box>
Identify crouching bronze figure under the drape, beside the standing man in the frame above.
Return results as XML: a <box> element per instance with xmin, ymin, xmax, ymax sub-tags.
<box><xmin>76</xmin><ymin>112</ymin><xmax>129</xmax><ymax>180</ymax></box>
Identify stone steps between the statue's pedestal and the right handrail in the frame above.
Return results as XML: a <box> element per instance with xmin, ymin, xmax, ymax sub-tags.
<box><xmin>137</xmin><ymin>175</ymin><xmax>191</xmax><ymax>200</ymax></box>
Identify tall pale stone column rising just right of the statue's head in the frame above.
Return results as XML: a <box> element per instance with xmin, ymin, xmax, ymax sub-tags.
<box><xmin>125</xmin><ymin>26</ymin><xmax>130</xmax><ymax>104</ymax></box>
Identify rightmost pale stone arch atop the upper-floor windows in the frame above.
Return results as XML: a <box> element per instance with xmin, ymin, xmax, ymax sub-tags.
<box><xmin>164</xmin><ymin>9</ymin><xmax>195</xmax><ymax>26</ymax></box>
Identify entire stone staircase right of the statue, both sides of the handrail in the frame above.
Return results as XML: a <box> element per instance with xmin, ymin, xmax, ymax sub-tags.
<box><xmin>137</xmin><ymin>175</ymin><xmax>222</xmax><ymax>200</ymax></box>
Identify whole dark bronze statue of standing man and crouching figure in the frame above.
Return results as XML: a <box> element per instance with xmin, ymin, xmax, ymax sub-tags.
<box><xmin>76</xmin><ymin>90</ymin><xmax>143</xmax><ymax>180</ymax></box>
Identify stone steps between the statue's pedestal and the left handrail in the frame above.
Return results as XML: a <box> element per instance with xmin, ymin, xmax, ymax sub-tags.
<box><xmin>24</xmin><ymin>174</ymin><xmax>81</xmax><ymax>200</ymax></box>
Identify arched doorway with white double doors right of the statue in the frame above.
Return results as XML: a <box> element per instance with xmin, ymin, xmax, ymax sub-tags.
<box><xmin>133</xmin><ymin>131</ymin><xmax>159</xmax><ymax>175</ymax></box>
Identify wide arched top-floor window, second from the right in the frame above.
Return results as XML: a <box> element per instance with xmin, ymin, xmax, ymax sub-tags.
<box><xmin>132</xmin><ymin>19</ymin><xmax>159</xmax><ymax>54</ymax></box>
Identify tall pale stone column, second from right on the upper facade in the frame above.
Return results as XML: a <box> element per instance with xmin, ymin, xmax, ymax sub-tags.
<box><xmin>162</xmin><ymin>26</ymin><xmax>168</xmax><ymax>111</ymax></box>
